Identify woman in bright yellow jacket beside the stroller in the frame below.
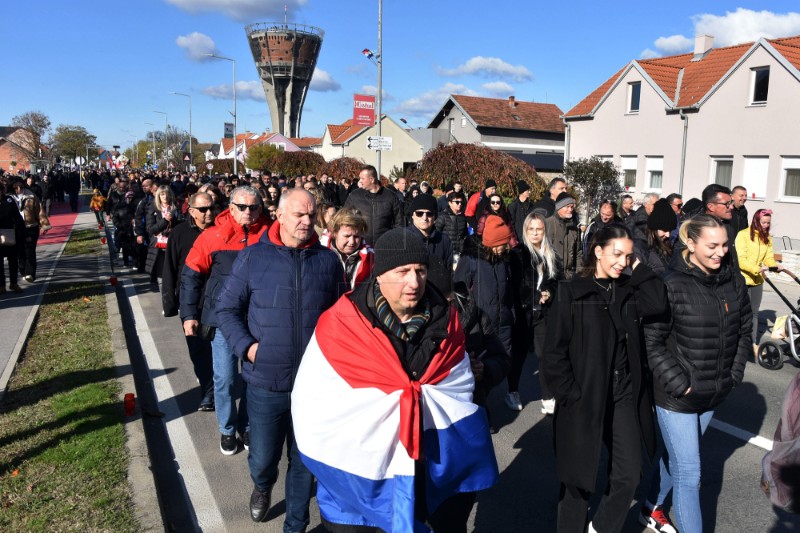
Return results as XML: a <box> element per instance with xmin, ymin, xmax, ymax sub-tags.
<box><xmin>736</xmin><ymin>209</ymin><xmax>783</xmax><ymax>353</ymax></box>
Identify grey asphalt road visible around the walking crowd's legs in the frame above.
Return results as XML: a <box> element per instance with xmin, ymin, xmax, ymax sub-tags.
<box><xmin>120</xmin><ymin>268</ymin><xmax>800</xmax><ymax>533</ymax></box>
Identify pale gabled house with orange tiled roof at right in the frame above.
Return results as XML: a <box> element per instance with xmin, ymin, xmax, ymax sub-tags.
<box><xmin>564</xmin><ymin>35</ymin><xmax>800</xmax><ymax>235</ymax></box>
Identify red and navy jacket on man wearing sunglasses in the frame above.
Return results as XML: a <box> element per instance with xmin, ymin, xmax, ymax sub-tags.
<box><xmin>180</xmin><ymin>209</ymin><xmax>267</xmax><ymax>327</ymax></box>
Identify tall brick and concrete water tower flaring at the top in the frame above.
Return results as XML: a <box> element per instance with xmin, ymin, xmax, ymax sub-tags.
<box><xmin>245</xmin><ymin>22</ymin><xmax>325</xmax><ymax>137</ymax></box>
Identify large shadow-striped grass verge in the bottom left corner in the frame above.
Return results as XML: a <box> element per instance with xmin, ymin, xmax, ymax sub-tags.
<box><xmin>0</xmin><ymin>254</ymin><xmax>138</xmax><ymax>532</ymax></box>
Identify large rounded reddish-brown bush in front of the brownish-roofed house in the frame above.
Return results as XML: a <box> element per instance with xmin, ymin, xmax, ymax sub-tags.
<box><xmin>406</xmin><ymin>143</ymin><xmax>545</xmax><ymax>198</ymax></box>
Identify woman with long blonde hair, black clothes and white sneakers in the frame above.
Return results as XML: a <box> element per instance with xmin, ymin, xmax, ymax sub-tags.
<box><xmin>506</xmin><ymin>213</ymin><xmax>562</xmax><ymax>415</ymax></box>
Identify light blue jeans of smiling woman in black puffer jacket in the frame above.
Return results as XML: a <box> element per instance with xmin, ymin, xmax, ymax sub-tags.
<box><xmin>648</xmin><ymin>406</ymin><xmax>714</xmax><ymax>533</ymax></box>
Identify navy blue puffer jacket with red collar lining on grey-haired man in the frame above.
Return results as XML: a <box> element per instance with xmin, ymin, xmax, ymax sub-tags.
<box><xmin>216</xmin><ymin>223</ymin><xmax>349</xmax><ymax>392</ymax></box>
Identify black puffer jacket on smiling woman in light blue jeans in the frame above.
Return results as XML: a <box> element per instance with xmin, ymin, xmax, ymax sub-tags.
<box><xmin>645</xmin><ymin>254</ymin><xmax>752</xmax><ymax>413</ymax></box>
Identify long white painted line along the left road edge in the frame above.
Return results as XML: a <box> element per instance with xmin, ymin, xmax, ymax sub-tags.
<box><xmin>120</xmin><ymin>280</ymin><xmax>226</xmax><ymax>531</ymax></box>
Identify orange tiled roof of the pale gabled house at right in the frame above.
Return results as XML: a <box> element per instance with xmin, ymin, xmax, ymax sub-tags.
<box><xmin>565</xmin><ymin>36</ymin><xmax>800</xmax><ymax>117</ymax></box>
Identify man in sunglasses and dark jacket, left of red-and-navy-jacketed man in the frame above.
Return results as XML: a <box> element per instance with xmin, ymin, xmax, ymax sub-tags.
<box><xmin>161</xmin><ymin>192</ymin><xmax>214</xmax><ymax>411</ymax></box>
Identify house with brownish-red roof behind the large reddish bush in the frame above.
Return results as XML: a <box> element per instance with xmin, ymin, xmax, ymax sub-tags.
<box><xmin>428</xmin><ymin>94</ymin><xmax>565</xmax><ymax>173</ymax></box>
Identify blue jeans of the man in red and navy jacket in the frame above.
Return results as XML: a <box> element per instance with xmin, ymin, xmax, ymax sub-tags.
<box><xmin>211</xmin><ymin>330</ymin><xmax>249</xmax><ymax>435</ymax></box>
